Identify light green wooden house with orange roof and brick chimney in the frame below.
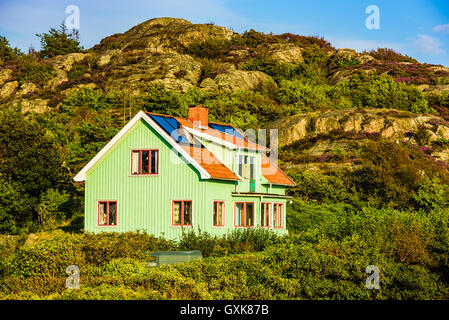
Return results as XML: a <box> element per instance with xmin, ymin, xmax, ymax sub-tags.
<box><xmin>74</xmin><ymin>106</ymin><xmax>294</xmax><ymax>239</ymax></box>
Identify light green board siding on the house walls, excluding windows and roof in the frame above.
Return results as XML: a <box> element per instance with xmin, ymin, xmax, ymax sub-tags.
<box><xmin>85</xmin><ymin>121</ymin><xmax>286</xmax><ymax>239</ymax></box>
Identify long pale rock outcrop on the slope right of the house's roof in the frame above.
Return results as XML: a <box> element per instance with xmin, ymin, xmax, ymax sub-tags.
<box><xmin>269</xmin><ymin>109</ymin><xmax>449</xmax><ymax>171</ymax></box>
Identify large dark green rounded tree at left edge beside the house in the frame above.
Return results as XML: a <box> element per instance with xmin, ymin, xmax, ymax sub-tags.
<box><xmin>0</xmin><ymin>110</ymin><xmax>68</xmax><ymax>233</ymax></box>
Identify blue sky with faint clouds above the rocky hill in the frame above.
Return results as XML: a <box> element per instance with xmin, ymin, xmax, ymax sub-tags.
<box><xmin>0</xmin><ymin>0</ymin><xmax>449</xmax><ymax>67</ymax></box>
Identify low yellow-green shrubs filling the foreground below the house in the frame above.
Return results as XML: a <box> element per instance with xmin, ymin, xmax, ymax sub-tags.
<box><xmin>0</xmin><ymin>201</ymin><xmax>449</xmax><ymax>300</ymax></box>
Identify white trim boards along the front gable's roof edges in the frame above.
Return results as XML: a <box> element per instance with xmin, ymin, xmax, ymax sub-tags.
<box><xmin>73</xmin><ymin>111</ymin><xmax>211</xmax><ymax>182</ymax></box>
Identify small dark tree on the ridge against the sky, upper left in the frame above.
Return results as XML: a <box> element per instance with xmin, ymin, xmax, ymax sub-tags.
<box><xmin>36</xmin><ymin>23</ymin><xmax>84</xmax><ymax>58</ymax></box>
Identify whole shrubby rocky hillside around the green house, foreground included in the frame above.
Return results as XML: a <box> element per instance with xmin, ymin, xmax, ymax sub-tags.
<box><xmin>0</xmin><ymin>18</ymin><xmax>449</xmax><ymax>300</ymax></box>
